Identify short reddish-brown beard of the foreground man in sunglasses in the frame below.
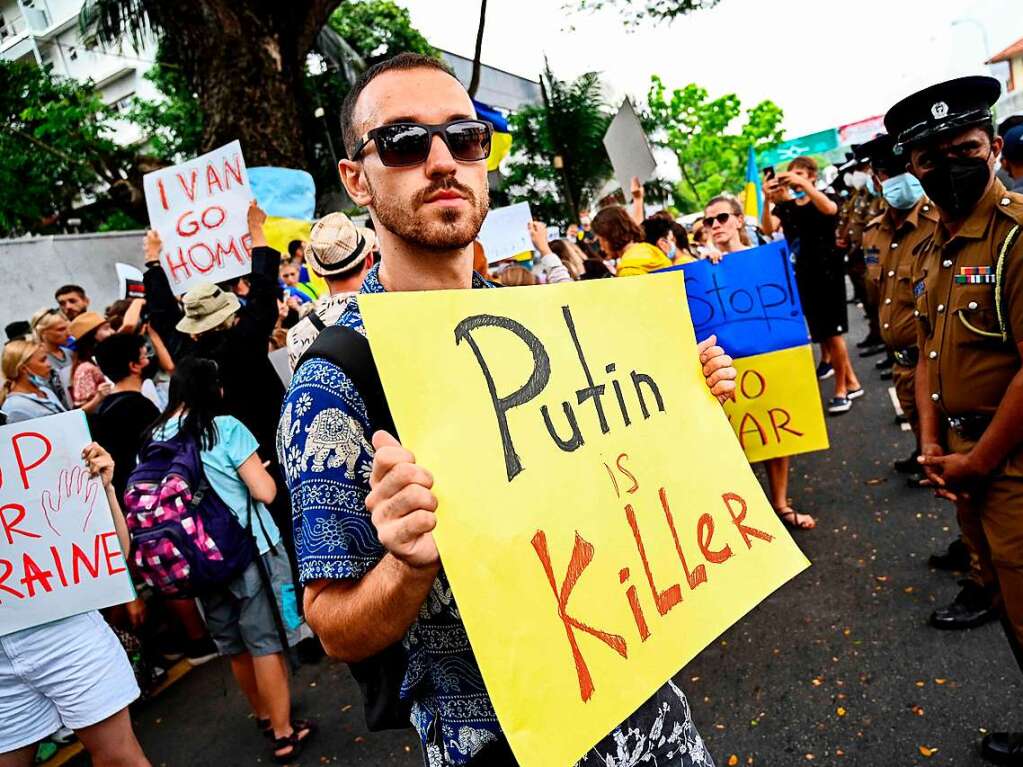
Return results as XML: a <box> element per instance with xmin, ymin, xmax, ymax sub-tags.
<box><xmin>367</xmin><ymin>177</ymin><xmax>490</xmax><ymax>251</ymax></box>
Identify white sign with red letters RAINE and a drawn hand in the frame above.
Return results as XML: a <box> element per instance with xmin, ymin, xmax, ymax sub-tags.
<box><xmin>0</xmin><ymin>410</ymin><xmax>135</xmax><ymax>635</ymax></box>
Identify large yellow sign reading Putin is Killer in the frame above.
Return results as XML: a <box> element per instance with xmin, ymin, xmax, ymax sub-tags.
<box><xmin>359</xmin><ymin>273</ymin><xmax>808</xmax><ymax>767</ymax></box>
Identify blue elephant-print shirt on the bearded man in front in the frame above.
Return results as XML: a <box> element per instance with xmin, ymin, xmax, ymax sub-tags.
<box><xmin>277</xmin><ymin>266</ymin><xmax>713</xmax><ymax>767</ymax></box>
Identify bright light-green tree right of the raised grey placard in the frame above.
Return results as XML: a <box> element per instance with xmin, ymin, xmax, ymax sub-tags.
<box><xmin>644</xmin><ymin>75</ymin><xmax>785</xmax><ymax>213</ymax></box>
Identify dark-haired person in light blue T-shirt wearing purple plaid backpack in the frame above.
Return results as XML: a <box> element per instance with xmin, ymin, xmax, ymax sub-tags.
<box><xmin>125</xmin><ymin>358</ymin><xmax>315</xmax><ymax>764</ymax></box>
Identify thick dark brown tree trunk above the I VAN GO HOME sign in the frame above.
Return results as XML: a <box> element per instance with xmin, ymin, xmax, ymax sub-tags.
<box><xmin>149</xmin><ymin>0</ymin><xmax>343</xmax><ymax>168</ymax></box>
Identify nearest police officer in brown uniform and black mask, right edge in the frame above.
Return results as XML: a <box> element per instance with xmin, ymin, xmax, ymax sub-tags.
<box><xmin>885</xmin><ymin>77</ymin><xmax>1023</xmax><ymax>765</ymax></box>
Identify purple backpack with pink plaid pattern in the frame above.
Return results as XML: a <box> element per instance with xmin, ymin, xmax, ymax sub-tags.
<box><xmin>124</xmin><ymin>438</ymin><xmax>257</xmax><ymax>597</ymax></box>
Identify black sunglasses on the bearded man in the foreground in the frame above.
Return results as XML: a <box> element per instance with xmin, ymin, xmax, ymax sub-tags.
<box><xmin>352</xmin><ymin>120</ymin><xmax>493</xmax><ymax>168</ymax></box>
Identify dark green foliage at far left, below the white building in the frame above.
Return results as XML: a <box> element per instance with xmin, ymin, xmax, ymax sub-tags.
<box><xmin>0</xmin><ymin>60</ymin><xmax>141</xmax><ymax>236</ymax></box>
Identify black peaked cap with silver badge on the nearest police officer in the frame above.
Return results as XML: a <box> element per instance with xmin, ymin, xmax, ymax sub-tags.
<box><xmin>885</xmin><ymin>76</ymin><xmax>1002</xmax><ymax>146</ymax></box>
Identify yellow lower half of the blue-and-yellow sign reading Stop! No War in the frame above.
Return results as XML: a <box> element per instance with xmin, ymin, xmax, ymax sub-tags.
<box><xmin>724</xmin><ymin>346</ymin><xmax>828</xmax><ymax>463</ymax></box>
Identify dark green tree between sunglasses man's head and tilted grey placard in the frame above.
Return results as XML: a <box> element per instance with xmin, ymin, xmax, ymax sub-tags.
<box><xmin>505</xmin><ymin>66</ymin><xmax>612</xmax><ymax>225</ymax></box>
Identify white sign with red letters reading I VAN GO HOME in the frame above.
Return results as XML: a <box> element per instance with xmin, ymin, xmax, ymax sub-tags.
<box><xmin>142</xmin><ymin>141</ymin><xmax>253</xmax><ymax>295</ymax></box>
